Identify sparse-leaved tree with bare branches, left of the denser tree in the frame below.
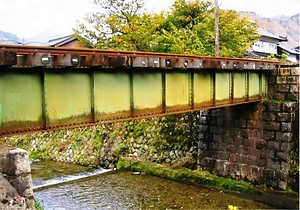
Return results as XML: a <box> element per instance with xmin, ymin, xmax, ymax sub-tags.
<box><xmin>73</xmin><ymin>0</ymin><xmax>162</xmax><ymax>51</ymax></box>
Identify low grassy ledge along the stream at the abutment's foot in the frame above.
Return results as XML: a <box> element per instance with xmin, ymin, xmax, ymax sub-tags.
<box><xmin>117</xmin><ymin>157</ymin><xmax>299</xmax><ymax>209</ymax></box>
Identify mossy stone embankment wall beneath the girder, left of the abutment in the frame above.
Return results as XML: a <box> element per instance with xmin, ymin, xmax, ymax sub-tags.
<box><xmin>0</xmin><ymin>113</ymin><xmax>293</xmax><ymax>207</ymax></box>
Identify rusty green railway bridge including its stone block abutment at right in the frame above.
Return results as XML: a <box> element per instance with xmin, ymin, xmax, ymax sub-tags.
<box><xmin>0</xmin><ymin>45</ymin><xmax>299</xmax><ymax>192</ymax></box>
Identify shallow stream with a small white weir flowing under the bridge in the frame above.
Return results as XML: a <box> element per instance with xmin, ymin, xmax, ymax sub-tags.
<box><xmin>31</xmin><ymin>161</ymin><xmax>274</xmax><ymax>210</ymax></box>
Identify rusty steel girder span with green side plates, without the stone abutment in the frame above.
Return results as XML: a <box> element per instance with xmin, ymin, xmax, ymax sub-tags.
<box><xmin>0</xmin><ymin>45</ymin><xmax>278</xmax><ymax>136</ymax></box>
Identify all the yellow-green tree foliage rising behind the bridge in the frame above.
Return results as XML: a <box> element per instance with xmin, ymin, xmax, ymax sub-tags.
<box><xmin>74</xmin><ymin>0</ymin><xmax>258</xmax><ymax>57</ymax></box>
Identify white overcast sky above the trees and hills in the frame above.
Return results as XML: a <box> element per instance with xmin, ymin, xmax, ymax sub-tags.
<box><xmin>0</xmin><ymin>0</ymin><xmax>300</xmax><ymax>38</ymax></box>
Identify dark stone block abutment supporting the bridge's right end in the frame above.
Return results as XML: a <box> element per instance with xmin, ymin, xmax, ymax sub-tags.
<box><xmin>198</xmin><ymin>66</ymin><xmax>299</xmax><ymax>189</ymax></box>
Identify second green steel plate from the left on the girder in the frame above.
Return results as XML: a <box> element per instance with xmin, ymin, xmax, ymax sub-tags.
<box><xmin>45</xmin><ymin>72</ymin><xmax>92</xmax><ymax>125</ymax></box>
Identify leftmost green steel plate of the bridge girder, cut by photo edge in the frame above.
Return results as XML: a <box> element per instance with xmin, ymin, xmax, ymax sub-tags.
<box><xmin>0</xmin><ymin>71</ymin><xmax>43</xmax><ymax>131</ymax></box>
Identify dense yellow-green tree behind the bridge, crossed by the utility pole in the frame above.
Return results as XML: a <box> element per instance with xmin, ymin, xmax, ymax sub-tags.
<box><xmin>157</xmin><ymin>0</ymin><xmax>258</xmax><ymax>57</ymax></box>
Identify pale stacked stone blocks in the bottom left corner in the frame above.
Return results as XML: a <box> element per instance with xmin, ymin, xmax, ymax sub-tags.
<box><xmin>0</xmin><ymin>143</ymin><xmax>35</xmax><ymax>209</ymax></box>
